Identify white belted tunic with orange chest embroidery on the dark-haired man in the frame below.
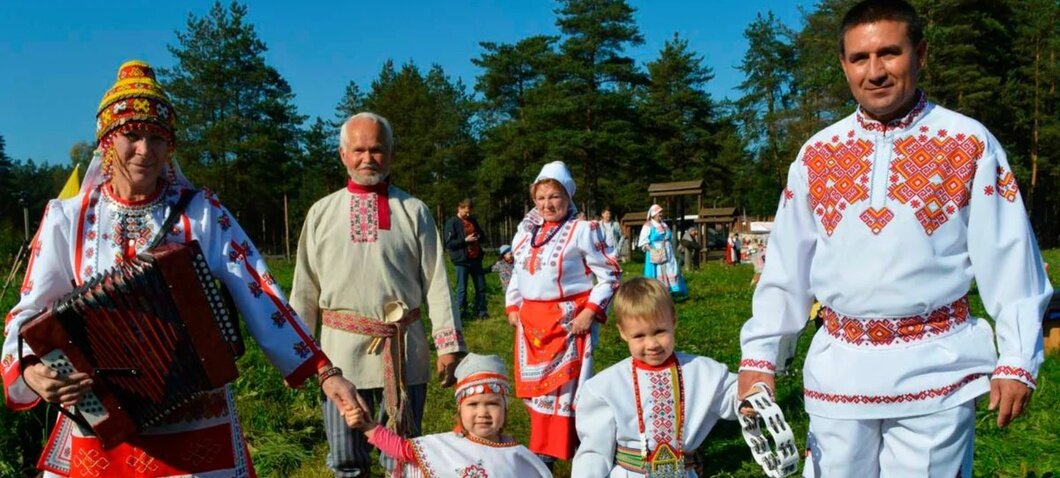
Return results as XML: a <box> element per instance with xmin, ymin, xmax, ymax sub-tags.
<box><xmin>741</xmin><ymin>93</ymin><xmax>1052</xmax><ymax>419</ymax></box>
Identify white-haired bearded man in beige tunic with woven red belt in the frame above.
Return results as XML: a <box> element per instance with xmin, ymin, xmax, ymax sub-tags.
<box><xmin>290</xmin><ymin>112</ymin><xmax>466</xmax><ymax>477</ymax></box>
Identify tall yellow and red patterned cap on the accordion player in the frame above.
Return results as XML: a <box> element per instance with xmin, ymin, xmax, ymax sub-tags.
<box><xmin>95</xmin><ymin>59</ymin><xmax>176</xmax><ymax>144</ymax></box>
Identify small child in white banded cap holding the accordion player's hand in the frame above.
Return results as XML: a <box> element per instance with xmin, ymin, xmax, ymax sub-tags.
<box><xmin>346</xmin><ymin>354</ymin><xmax>552</xmax><ymax>478</ymax></box>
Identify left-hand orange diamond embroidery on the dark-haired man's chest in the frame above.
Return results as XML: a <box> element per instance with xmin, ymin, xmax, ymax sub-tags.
<box><xmin>802</xmin><ymin>137</ymin><xmax>872</xmax><ymax>235</ymax></box>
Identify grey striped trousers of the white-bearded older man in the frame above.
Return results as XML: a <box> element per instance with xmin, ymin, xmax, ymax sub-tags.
<box><xmin>322</xmin><ymin>384</ymin><xmax>427</xmax><ymax>478</ymax></box>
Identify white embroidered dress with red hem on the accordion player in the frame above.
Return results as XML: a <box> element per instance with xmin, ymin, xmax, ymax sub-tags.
<box><xmin>2</xmin><ymin>181</ymin><xmax>326</xmax><ymax>477</ymax></box>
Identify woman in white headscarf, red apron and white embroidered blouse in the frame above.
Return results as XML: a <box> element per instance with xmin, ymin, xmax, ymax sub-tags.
<box><xmin>505</xmin><ymin>161</ymin><xmax>622</xmax><ymax>463</ymax></box>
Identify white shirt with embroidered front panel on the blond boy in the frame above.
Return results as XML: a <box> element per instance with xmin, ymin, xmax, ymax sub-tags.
<box><xmin>570</xmin><ymin>352</ymin><xmax>737</xmax><ymax>478</ymax></box>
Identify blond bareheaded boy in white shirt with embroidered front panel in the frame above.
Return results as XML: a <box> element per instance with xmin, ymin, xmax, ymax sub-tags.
<box><xmin>571</xmin><ymin>278</ymin><xmax>737</xmax><ymax>477</ymax></box>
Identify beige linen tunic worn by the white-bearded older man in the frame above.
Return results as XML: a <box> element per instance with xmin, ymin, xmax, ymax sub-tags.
<box><xmin>290</xmin><ymin>185</ymin><xmax>466</xmax><ymax>388</ymax></box>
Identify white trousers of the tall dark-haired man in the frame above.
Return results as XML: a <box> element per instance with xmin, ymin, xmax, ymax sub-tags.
<box><xmin>802</xmin><ymin>400</ymin><xmax>975</xmax><ymax>478</ymax></box>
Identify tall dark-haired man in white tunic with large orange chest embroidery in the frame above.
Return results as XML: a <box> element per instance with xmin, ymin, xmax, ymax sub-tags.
<box><xmin>740</xmin><ymin>0</ymin><xmax>1052</xmax><ymax>477</ymax></box>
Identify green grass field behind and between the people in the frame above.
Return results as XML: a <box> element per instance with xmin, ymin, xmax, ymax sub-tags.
<box><xmin>0</xmin><ymin>250</ymin><xmax>1060</xmax><ymax>478</ymax></box>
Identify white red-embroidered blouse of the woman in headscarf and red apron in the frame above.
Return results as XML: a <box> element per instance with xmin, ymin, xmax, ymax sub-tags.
<box><xmin>505</xmin><ymin>219</ymin><xmax>622</xmax><ymax>317</ymax></box>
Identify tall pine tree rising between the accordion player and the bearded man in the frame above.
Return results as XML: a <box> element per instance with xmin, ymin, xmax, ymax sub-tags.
<box><xmin>161</xmin><ymin>1</ymin><xmax>304</xmax><ymax>252</ymax></box>
